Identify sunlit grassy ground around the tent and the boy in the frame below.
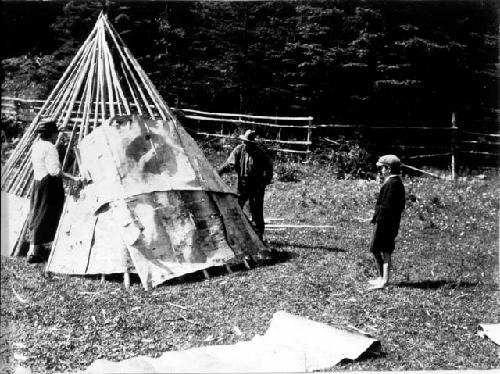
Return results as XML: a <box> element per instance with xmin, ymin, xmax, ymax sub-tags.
<box><xmin>1</xmin><ymin>160</ymin><xmax>500</xmax><ymax>372</ymax></box>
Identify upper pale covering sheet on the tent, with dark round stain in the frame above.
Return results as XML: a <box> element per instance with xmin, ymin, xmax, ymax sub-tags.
<box><xmin>78</xmin><ymin>116</ymin><xmax>234</xmax><ymax>206</ymax></box>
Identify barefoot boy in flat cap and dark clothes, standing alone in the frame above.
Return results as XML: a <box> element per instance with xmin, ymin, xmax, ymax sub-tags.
<box><xmin>369</xmin><ymin>155</ymin><xmax>405</xmax><ymax>289</ymax></box>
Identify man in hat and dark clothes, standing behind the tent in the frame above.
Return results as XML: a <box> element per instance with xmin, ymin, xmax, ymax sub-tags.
<box><xmin>217</xmin><ymin>130</ymin><xmax>273</xmax><ymax>240</ymax></box>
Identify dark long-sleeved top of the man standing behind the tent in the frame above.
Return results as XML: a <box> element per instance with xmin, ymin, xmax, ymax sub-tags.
<box><xmin>218</xmin><ymin>144</ymin><xmax>273</xmax><ymax>185</ymax></box>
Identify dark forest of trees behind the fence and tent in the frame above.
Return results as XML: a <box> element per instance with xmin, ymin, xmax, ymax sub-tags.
<box><xmin>1</xmin><ymin>1</ymin><xmax>499</xmax><ymax>133</ymax></box>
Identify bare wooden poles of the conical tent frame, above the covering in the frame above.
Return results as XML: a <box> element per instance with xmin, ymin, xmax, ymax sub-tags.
<box><xmin>1</xmin><ymin>12</ymin><xmax>177</xmax><ymax>258</ymax></box>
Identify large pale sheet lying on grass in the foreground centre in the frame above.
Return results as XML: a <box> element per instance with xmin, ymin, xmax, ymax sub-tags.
<box><xmin>85</xmin><ymin>311</ymin><xmax>380</xmax><ymax>374</ymax></box>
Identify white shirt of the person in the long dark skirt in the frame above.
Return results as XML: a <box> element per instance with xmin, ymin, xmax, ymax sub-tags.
<box><xmin>31</xmin><ymin>140</ymin><xmax>61</xmax><ymax>181</ymax></box>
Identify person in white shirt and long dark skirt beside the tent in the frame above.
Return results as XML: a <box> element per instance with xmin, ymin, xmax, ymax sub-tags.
<box><xmin>28</xmin><ymin>120</ymin><xmax>80</xmax><ymax>263</ymax></box>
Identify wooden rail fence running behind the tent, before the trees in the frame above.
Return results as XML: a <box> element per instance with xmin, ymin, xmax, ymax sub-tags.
<box><xmin>2</xmin><ymin>97</ymin><xmax>500</xmax><ymax>174</ymax></box>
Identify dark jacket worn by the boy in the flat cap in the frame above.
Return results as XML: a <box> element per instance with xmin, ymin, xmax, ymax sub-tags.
<box><xmin>371</xmin><ymin>176</ymin><xmax>405</xmax><ymax>226</ymax></box>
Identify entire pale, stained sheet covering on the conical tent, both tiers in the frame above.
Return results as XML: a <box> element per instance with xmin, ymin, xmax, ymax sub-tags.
<box><xmin>47</xmin><ymin>117</ymin><xmax>267</xmax><ymax>288</ymax></box>
